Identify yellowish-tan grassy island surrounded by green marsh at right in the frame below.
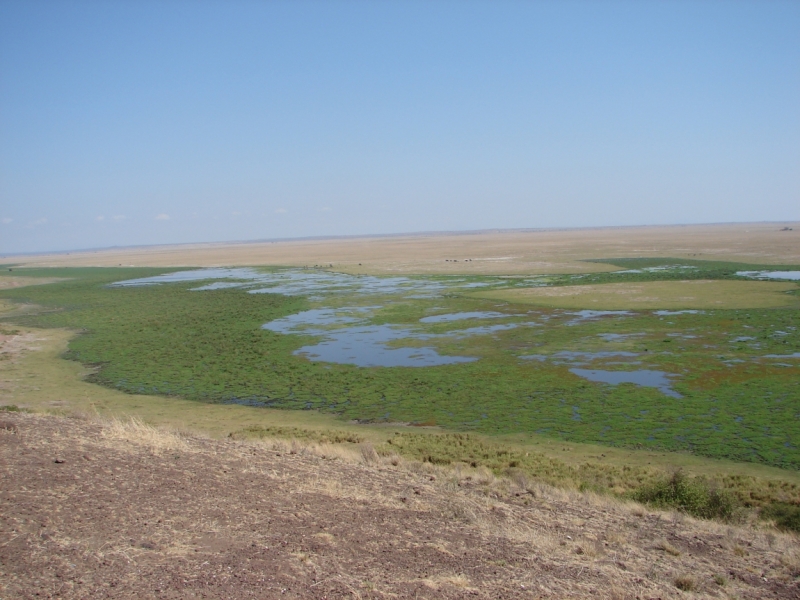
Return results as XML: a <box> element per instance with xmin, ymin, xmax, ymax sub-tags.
<box><xmin>470</xmin><ymin>280</ymin><xmax>800</xmax><ymax>310</ymax></box>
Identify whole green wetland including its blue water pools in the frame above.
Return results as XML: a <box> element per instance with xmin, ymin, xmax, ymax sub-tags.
<box><xmin>0</xmin><ymin>259</ymin><xmax>800</xmax><ymax>469</ymax></box>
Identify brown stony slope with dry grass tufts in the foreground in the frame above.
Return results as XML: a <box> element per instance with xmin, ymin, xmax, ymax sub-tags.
<box><xmin>0</xmin><ymin>413</ymin><xmax>800</xmax><ymax>599</ymax></box>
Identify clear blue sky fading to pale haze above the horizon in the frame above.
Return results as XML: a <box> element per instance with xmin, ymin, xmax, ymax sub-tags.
<box><xmin>0</xmin><ymin>0</ymin><xmax>800</xmax><ymax>253</ymax></box>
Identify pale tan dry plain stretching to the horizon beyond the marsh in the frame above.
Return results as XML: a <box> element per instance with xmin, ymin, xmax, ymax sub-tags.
<box><xmin>0</xmin><ymin>223</ymin><xmax>800</xmax><ymax>274</ymax></box>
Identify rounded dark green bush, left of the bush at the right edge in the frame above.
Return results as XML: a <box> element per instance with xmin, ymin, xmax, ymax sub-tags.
<box><xmin>631</xmin><ymin>470</ymin><xmax>737</xmax><ymax>520</ymax></box>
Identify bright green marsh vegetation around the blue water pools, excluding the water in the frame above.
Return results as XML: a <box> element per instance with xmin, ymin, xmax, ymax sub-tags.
<box><xmin>0</xmin><ymin>259</ymin><xmax>800</xmax><ymax>474</ymax></box>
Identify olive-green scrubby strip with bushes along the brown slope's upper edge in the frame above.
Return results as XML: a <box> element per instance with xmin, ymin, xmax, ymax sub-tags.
<box><xmin>230</xmin><ymin>427</ymin><xmax>800</xmax><ymax>516</ymax></box>
